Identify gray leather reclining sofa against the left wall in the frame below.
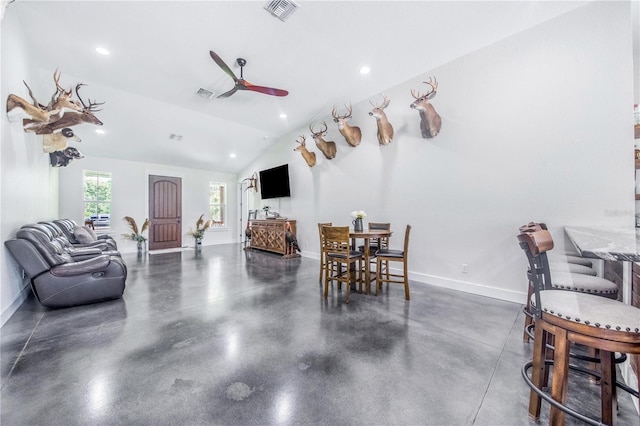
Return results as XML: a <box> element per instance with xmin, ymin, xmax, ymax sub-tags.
<box><xmin>5</xmin><ymin>221</ymin><xmax>127</xmax><ymax>308</ymax></box>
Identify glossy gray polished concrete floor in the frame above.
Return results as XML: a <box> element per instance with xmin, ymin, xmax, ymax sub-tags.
<box><xmin>0</xmin><ymin>244</ymin><xmax>640</xmax><ymax>426</ymax></box>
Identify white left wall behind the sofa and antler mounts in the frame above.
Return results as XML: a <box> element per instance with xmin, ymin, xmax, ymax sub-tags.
<box><xmin>0</xmin><ymin>5</ymin><xmax>58</xmax><ymax>324</ymax></box>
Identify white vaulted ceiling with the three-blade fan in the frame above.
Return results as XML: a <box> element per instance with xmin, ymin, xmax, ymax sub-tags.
<box><xmin>2</xmin><ymin>0</ymin><xmax>596</xmax><ymax>173</ymax></box>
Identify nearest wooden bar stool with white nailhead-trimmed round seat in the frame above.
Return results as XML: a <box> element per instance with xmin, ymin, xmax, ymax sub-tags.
<box><xmin>518</xmin><ymin>229</ymin><xmax>640</xmax><ymax>426</ymax></box>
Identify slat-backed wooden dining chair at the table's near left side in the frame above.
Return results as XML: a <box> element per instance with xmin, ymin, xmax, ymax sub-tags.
<box><xmin>322</xmin><ymin>226</ymin><xmax>364</xmax><ymax>303</ymax></box>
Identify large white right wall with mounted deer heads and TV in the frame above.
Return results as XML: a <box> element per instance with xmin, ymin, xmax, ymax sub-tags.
<box><xmin>242</xmin><ymin>2</ymin><xmax>634</xmax><ymax>303</ymax></box>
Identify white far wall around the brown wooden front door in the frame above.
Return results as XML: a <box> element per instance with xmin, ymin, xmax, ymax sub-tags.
<box><xmin>59</xmin><ymin>156</ymin><xmax>239</xmax><ymax>252</ymax></box>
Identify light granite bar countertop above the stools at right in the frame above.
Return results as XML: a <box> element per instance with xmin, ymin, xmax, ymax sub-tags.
<box><xmin>564</xmin><ymin>226</ymin><xmax>640</xmax><ymax>262</ymax></box>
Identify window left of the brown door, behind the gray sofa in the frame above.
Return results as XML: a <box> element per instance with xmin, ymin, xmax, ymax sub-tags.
<box><xmin>82</xmin><ymin>170</ymin><xmax>111</xmax><ymax>227</ymax></box>
